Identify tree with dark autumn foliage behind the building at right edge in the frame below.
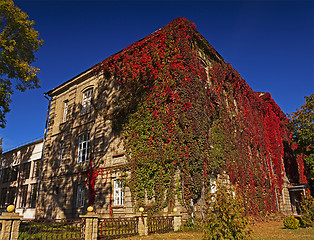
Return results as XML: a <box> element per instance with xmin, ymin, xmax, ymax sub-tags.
<box><xmin>289</xmin><ymin>94</ymin><xmax>314</xmax><ymax>189</ymax></box>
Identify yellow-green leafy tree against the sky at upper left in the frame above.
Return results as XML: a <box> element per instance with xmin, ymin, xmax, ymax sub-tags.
<box><xmin>0</xmin><ymin>0</ymin><xmax>43</xmax><ymax>128</ymax></box>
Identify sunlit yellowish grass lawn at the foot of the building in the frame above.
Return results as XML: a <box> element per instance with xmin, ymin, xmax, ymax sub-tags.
<box><xmin>119</xmin><ymin>222</ymin><xmax>314</xmax><ymax>240</ymax></box>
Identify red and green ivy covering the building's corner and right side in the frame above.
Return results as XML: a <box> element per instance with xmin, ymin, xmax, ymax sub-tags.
<box><xmin>94</xmin><ymin>18</ymin><xmax>306</xmax><ymax>214</ymax></box>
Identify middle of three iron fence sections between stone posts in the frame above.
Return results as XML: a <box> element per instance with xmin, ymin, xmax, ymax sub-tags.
<box><xmin>98</xmin><ymin>217</ymin><xmax>138</xmax><ymax>239</ymax></box>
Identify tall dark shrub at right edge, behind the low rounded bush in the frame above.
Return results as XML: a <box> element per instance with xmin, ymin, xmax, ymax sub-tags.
<box><xmin>300</xmin><ymin>195</ymin><xmax>314</xmax><ymax>227</ymax></box>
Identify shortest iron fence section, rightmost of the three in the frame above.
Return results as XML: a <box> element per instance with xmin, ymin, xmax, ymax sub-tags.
<box><xmin>147</xmin><ymin>216</ymin><xmax>173</xmax><ymax>233</ymax></box>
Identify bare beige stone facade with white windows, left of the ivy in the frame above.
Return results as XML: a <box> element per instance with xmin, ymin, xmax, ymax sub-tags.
<box><xmin>38</xmin><ymin>71</ymin><xmax>133</xmax><ymax>218</ymax></box>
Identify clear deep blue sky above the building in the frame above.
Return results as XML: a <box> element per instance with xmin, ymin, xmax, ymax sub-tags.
<box><xmin>0</xmin><ymin>0</ymin><xmax>314</xmax><ymax>150</ymax></box>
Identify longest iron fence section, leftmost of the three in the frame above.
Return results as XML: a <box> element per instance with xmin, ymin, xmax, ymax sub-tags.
<box><xmin>18</xmin><ymin>219</ymin><xmax>85</xmax><ymax>240</ymax></box>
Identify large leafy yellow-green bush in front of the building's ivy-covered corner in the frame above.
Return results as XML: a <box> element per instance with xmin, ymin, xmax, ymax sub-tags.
<box><xmin>203</xmin><ymin>185</ymin><xmax>251</xmax><ymax>240</ymax></box>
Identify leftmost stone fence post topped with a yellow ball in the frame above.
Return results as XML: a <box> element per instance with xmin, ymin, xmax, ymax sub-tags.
<box><xmin>0</xmin><ymin>205</ymin><xmax>22</xmax><ymax>240</ymax></box>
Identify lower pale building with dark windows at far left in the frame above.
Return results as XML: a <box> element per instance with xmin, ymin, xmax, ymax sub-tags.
<box><xmin>0</xmin><ymin>139</ymin><xmax>43</xmax><ymax>219</ymax></box>
